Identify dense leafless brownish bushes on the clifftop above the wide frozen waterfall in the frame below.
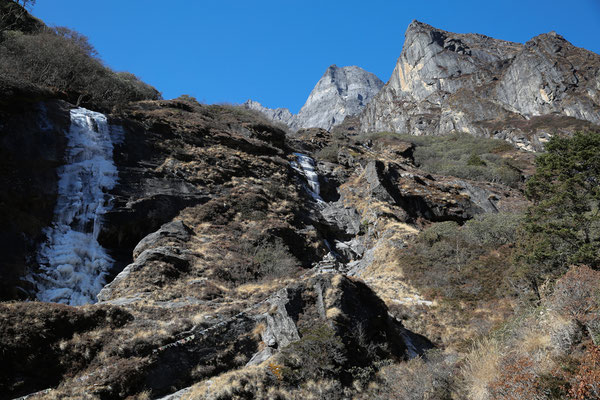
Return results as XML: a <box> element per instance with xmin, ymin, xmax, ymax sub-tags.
<box><xmin>0</xmin><ymin>27</ymin><xmax>160</xmax><ymax>110</ymax></box>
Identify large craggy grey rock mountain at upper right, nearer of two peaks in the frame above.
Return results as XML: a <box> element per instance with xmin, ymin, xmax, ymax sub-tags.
<box><xmin>360</xmin><ymin>21</ymin><xmax>600</xmax><ymax>150</ymax></box>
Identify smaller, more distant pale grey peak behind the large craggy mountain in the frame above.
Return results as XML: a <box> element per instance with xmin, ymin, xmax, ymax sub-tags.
<box><xmin>244</xmin><ymin>65</ymin><xmax>383</xmax><ymax>131</ymax></box>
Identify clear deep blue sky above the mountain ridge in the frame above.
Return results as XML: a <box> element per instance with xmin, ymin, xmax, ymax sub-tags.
<box><xmin>33</xmin><ymin>0</ymin><xmax>600</xmax><ymax>112</ymax></box>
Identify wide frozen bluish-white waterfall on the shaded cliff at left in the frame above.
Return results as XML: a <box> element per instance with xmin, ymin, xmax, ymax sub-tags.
<box><xmin>29</xmin><ymin>108</ymin><xmax>117</xmax><ymax>305</ymax></box>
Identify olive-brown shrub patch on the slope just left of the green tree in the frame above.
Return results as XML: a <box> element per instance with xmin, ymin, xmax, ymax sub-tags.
<box><xmin>400</xmin><ymin>213</ymin><xmax>520</xmax><ymax>301</ymax></box>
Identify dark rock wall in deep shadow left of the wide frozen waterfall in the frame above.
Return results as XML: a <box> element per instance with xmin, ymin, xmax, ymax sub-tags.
<box><xmin>0</xmin><ymin>99</ymin><xmax>70</xmax><ymax>300</ymax></box>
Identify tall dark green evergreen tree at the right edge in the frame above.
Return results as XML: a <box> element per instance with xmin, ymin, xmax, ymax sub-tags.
<box><xmin>517</xmin><ymin>133</ymin><xmax>600</xmax><ymax>285</ymax></box>
